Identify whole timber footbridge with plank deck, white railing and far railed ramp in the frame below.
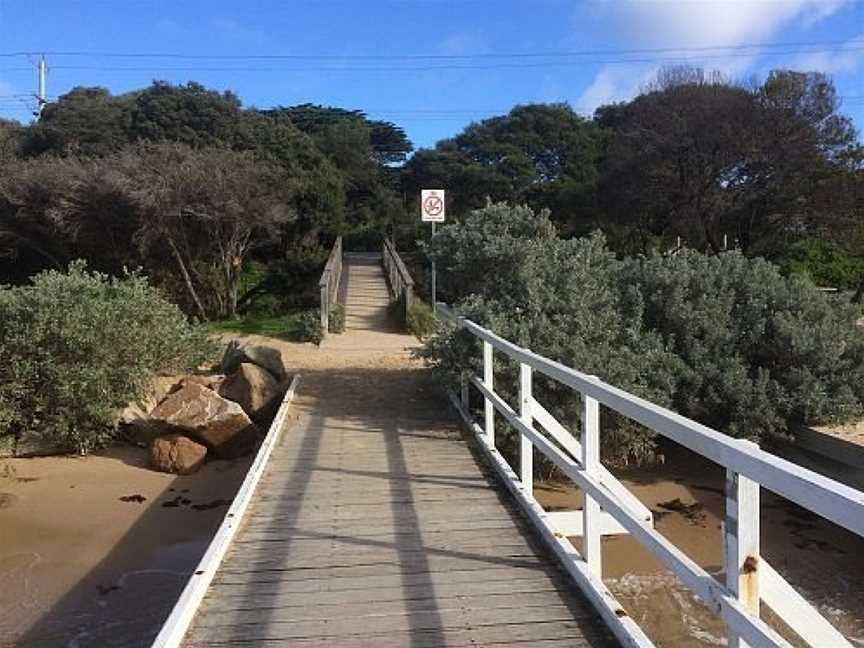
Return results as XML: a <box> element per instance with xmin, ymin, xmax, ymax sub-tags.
<box><xmin>154</xmin><ymin>241</ymin><xmax>864</xmax><ymax>648</ymax></box>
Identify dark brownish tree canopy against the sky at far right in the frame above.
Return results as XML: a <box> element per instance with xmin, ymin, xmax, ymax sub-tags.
<box><xmin>596</xmin><ymin>68</ymin><xmax>862</xmax><ymax>252</ymax></box>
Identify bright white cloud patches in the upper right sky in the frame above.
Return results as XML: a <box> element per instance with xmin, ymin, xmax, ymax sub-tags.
<box><xmin>576</xmin><ymin>0</ymin><xmax>858</xmax><ymax>109</ymax></box>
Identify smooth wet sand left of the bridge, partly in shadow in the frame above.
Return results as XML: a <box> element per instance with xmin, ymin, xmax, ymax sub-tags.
<box><xmin>0</xmin><ymin>447</ymin><xmax>251</xmax><ymax>648</ymax></box>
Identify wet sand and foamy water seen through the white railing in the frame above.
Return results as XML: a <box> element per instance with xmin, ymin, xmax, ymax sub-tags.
<box><xmin>535</xmin><ymin>450</ymin><xmax>864</xmax><ymax>648</ymax></box>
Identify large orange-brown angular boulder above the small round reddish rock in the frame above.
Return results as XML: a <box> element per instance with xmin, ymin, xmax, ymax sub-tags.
<box><xmin>150</xmin><ymin>383</ymin><xmax>258</xmax><ymax>458</ymax></box>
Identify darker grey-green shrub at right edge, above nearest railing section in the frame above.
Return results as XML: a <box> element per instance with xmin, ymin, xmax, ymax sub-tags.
<box><xmin>618</xmin><ymin>250</ymin><xmax>864</xmax><ymax>441</ymax></box>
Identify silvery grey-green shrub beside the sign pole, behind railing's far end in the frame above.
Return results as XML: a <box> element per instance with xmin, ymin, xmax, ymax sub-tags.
<box><xmin>424</xmin><ymin>204</ymin><xmax>677</xmax><ymax>464</ymax></box>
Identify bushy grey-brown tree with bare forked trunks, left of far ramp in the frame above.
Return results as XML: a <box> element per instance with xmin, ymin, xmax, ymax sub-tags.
<box><xmin>126</xmin><ymin>144</ymin><xmax>294</xmax><ymax>320</ymax></box>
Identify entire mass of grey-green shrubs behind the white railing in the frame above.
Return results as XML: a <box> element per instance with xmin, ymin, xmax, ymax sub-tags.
<box><xmin>424</xmin><ymin>204</ymin><xmax>864</xmax><ymax>464</ymax></box>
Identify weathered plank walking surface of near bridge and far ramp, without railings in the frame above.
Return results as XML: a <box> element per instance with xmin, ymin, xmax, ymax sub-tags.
<box><xmin>186</xmin><ymin>257</ymin><xmax>613</xmax><ymax>648</ymax></box>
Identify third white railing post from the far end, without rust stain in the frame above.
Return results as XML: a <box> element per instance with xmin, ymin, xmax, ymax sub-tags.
<box><xmin>581</xmin><ymin>394</ymin><xmax>603</xmax><ymax>578</ymax></box>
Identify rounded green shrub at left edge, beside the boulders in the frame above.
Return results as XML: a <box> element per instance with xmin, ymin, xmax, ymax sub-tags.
<box><xmin>0</xmin><ymin>261</ymin><xmax>215</xmax><ymax>453</ymax></box>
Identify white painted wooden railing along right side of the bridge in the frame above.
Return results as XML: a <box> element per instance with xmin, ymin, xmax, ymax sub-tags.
<box><xmin>439</xmin><ymin>304</ymin><xmax>864</xmax><ymax>648</ymax></box>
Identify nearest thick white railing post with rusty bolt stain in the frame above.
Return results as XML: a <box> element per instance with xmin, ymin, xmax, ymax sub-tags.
<box><xmin>724</xmin><ymin>441</ymin><xmax>760</xmax><ymax>648</ymax></box>
